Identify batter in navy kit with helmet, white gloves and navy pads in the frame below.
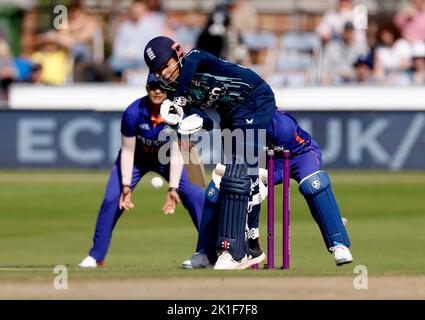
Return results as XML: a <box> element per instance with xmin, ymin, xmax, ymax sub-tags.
<box><xmin>144</xmin><ymin>36</ymin><xmax>276</xmax><ymax>270</ymax></box>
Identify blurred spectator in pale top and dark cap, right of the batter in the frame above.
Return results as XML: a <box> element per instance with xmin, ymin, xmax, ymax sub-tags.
<box><xmin>322</xmin><ymin>22</ymin><xmax>368</xmax><ymax>85</ymax></box>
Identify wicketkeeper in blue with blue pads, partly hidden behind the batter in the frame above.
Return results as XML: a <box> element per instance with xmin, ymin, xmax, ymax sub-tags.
<box><xmin>182</xmin><ymin>110</ymin><xmax>353</xmax><ymax>269</ymax></box>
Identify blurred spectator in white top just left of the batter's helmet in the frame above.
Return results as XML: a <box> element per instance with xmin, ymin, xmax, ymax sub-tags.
<box><xmin>110</xmin><ymin>1</ymin><xmax>165</xmax><ymax>76</ymax></box>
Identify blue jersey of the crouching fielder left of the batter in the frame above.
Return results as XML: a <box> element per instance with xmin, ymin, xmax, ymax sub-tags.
<box><xmin>121</xmin><ymin>96</ymin><xmax>166</xmax><ymax>160</ymax></box>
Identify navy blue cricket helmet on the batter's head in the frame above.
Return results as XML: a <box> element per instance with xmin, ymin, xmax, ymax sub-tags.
<box><xmin>144</xmin><ymin>36</ymin><xmax>184</xmax><ymax>73</ymax></box>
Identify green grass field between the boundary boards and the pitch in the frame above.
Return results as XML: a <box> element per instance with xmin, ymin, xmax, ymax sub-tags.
<box><xmin>0</xmin><ymin>171</ymin><xmax>425</xmax><ymax>280</ymax></box>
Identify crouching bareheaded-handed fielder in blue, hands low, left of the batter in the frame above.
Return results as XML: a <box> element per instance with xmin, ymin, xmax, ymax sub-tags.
<box><xmin>79</xmin><ymin>74</ymin><xmax>204</xmax><ymax>268</ymax></box>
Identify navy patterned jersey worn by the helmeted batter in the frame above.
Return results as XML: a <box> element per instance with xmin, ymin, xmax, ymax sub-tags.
<box><xmin>174</xmin><ymin>49</ymin><xmax>264</xmax><ymax>114</ymax></box>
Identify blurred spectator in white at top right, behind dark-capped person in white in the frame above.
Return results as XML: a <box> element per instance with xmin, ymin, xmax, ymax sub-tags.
<box><xmin>316</xmin><ymin>0</ymin><xmax>366</xmax><ymax>46</ymax></box>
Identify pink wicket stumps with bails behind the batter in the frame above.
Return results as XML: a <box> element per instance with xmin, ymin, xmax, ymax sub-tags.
<box><xmin>266</xmin><ymin>147</ymin><xmax>290</xmax><ymax>270</ymax></box>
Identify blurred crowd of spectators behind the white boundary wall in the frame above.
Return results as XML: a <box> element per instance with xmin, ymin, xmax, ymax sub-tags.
<box><xmin>0</xmin><ymin>0</ymin><xmax>425</xmax><ymax>100</ymax></box>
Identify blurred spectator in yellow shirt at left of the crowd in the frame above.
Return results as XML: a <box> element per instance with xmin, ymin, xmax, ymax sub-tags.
<box><xmin>31</xmin><ymin>31</ymin><xmax>70</xmax><ymax>85</ymax></box>
